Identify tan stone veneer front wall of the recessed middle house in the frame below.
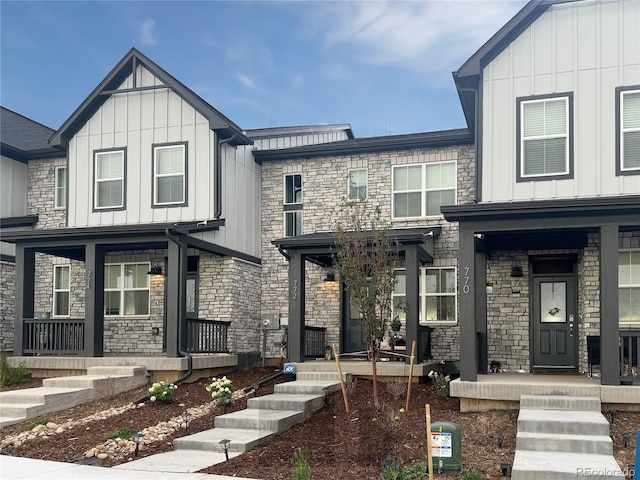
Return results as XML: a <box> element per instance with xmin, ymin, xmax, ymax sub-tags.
<box><xmin>262</xmin><ymin>145</ymin><xmax>474</xmax><ymax>360</ymax></box>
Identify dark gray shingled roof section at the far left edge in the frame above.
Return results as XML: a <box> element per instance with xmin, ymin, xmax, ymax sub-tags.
<box><xmin>0</xmin><ymin>107</ymin><xmax>65</xmax><ymax>163</ymax></box>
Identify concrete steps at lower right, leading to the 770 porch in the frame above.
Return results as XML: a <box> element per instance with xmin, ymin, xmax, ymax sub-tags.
<box><xmin>511</xmin><ymin>395</ymin><xmax>624</xmax><ymax>480</ymax></box>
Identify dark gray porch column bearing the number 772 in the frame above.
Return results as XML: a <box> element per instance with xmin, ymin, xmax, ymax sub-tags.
<box><xmin>287</xmin><ymin>252</ymin><xmax>305</xmax><ymax>362</ymax></box>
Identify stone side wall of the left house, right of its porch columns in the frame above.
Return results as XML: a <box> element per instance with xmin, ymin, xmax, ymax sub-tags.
<box><xmin>198</xmin><ymin>254</ymin><xmax>261</xmax><ymax>352</ymax></box>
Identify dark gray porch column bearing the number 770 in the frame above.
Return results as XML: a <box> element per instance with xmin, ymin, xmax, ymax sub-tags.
<box><xmin>458</xmin><ymin>227</ymin><xmax>478</xmax><ymax>382</ymax></box>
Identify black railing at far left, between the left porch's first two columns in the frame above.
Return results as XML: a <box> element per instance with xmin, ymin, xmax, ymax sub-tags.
<box><xmin>22</xmin><ymin>318</ymin><xmax>84</xmax><ymax>355</ymax></box>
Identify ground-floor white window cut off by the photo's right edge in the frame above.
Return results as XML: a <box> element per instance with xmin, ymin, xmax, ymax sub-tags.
<box><xmin>618</xmin><ymin>250</ymin><xmax>640</xmax><ymax>323</ymax></box>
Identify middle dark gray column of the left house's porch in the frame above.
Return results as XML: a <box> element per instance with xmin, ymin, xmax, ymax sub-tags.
<box><xmin>84</xmin><ymin>243</ymin><xmax>104</xmax><ymax>357</ymax></box>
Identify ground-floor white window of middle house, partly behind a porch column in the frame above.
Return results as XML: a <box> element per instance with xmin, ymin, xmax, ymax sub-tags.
<box><xmin>393</xmin><ymin>267</ymin><xmax>458</xmax><ymax>323</ymax></box>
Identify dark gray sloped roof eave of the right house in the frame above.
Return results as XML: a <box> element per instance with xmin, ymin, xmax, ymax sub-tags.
<box><xmin>453</xmin><ymin>0</ymin><xmax>582</xmax><ymax>131</ymax></box>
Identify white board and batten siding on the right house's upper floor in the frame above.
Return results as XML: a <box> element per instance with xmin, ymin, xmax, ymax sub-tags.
<box><xmin>481</xmin><ymin>0</ymin><xmax>640</xmax><ymax>202</ymax></box>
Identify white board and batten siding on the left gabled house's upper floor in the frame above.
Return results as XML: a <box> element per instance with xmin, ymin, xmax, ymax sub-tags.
<box><xmin>68</xmin><ymin>66</ymin><xmax>260</xmax><ymax>256</ymax></box>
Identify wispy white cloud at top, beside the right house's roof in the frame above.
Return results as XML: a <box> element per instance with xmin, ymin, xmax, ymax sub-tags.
<box><xmin>309</xmin><ymin>0</ymin><xmax>526</xmax><ymax>81</ymax></box>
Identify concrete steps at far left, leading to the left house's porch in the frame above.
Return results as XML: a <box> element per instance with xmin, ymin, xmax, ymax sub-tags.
<box><xmin>0</xmin><ymin>366</ymin><xmax>147</xmax><ymax>428</ymax></box>
